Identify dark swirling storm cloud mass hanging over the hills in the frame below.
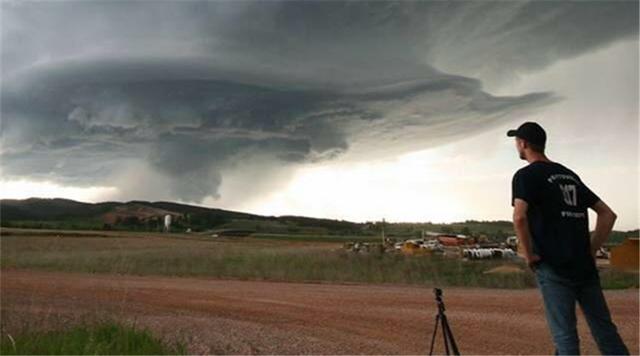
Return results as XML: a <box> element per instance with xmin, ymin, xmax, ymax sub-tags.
<box><xmin>0</xmin><ymin>1</ymin><xmax>638</xmax><ymax>202</ymax></box>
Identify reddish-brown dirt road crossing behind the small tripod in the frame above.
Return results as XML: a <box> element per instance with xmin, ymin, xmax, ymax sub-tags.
<box><xmin>1</xmin><ymin>270</ymin><xmax>639</xmax><ymax>354</ymax></box>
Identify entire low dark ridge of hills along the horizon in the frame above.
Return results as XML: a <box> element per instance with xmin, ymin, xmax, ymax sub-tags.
<box><xmin>0</xmin><ymin>198</ymin><xmax>638</xmax><ymax>243</ymax></box>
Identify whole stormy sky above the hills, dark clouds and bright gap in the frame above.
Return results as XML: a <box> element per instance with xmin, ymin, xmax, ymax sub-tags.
<box><xmin>0</xmin><ymin>1</ymin><xmax>640</xmax><ymax>229</ymax></box>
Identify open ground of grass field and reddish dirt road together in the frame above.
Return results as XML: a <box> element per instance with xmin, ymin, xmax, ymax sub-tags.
<box><xmin>0</xmin><ymin>229</ymin><xmax>639</xmax><ymax>354</ymax></box>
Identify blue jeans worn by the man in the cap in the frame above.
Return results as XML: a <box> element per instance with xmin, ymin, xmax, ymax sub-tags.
<box><xmin>535</xmin><ymin>261</ymin><xmax>629</xmax><ymax>355</ymax></box>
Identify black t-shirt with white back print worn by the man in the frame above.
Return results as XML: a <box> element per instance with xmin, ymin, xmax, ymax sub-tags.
<box><xmin>511</xmin><ymin>161</ymin><xmax>600</xmax><ymax>279</ymax></box>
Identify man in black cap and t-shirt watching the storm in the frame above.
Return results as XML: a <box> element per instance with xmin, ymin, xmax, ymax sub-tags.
<box><xmin>507</xmin><ymin>122</ymin><xmax>629</xmax><ymax>355</ymax></box>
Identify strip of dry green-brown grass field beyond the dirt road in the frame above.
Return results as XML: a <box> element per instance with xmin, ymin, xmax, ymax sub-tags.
<box><xmin>0</xmin><ymin>230</ymin><xmax>638</xmax><ymax>288</ymax></box>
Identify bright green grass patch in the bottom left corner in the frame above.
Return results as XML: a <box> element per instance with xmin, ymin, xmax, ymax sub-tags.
<box><xmin>0</xmin><ymin>322</ymin><xmax>186</xmax><ymax>355</ymax></box>
